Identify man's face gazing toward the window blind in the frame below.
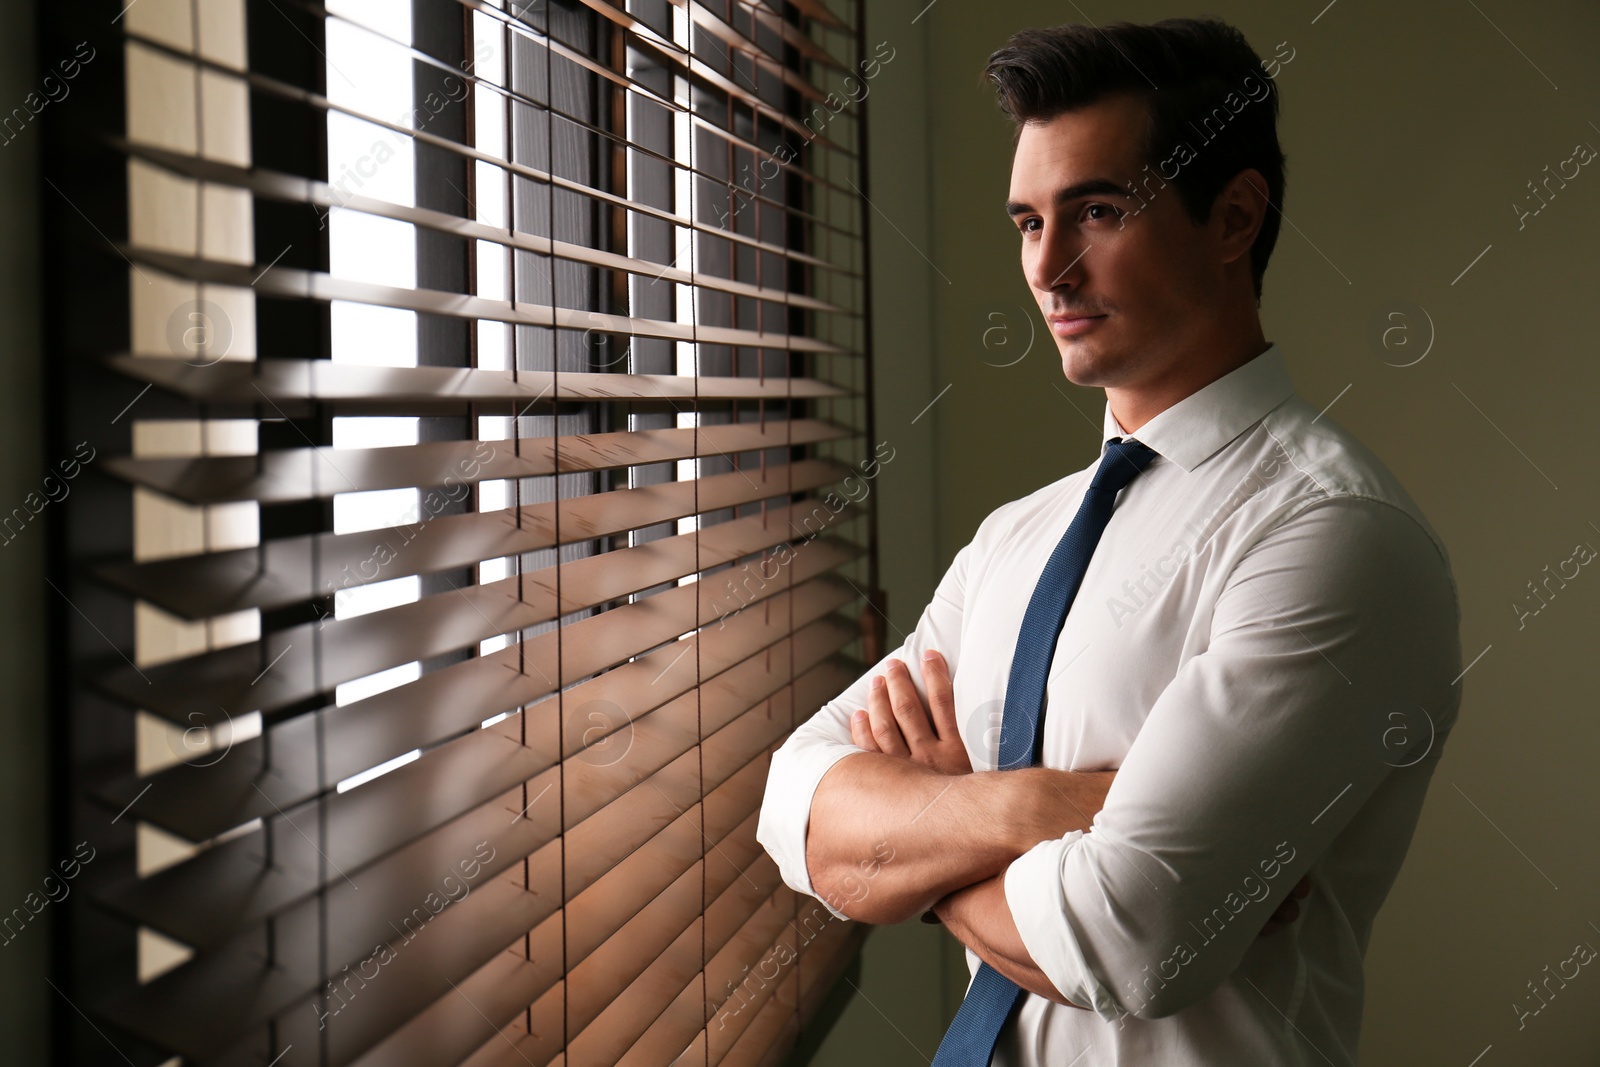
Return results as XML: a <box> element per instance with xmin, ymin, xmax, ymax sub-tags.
<box><xmin>1006</xmin><ymin>96</ymin><xmax>1226</xmax><ymax>389</ymax></box>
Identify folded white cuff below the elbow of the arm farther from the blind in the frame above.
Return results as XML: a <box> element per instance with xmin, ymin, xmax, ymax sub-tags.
<box><xmin>1003</xmin><ymin>830</ymin><xmax>1128</xmax><ymax>1022</ymax></box>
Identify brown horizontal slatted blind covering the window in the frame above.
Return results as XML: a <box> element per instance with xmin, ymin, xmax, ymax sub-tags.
<box><xmin>45</xmin><ymin>0</ymin><xmax>893</xmax><ymax>1067</ymax></box>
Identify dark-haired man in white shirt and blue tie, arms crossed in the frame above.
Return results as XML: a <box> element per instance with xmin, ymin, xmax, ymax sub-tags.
<box><xmin>757</xmin><ymin>19</ymin><xmax>1461</xmax><ymax>1067</ymax></box>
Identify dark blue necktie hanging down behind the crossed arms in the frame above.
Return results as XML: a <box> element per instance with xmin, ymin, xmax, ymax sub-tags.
<box><xmin>933</xmin><ymin>437</ymin><xmax>1155</xmax><ymax>1067</ymax></box>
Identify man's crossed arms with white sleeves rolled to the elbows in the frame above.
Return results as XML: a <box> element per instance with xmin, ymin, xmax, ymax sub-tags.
<box><xmin>757</xmin><ymin>496</ymin><xmax>1461</xmax><ymax>1021</ymax></box>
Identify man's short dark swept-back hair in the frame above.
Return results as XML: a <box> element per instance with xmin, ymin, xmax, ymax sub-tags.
<box><xmin>984</xmin><ymin>19</ymin><xmax>1293</xmax><ymax>302</ymax></box>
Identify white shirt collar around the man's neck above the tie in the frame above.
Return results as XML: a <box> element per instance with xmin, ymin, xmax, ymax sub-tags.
<box><xmin>1101</xmin><ymin>342</ymin><xmax>1294</xmax><ymax>470</ymax></box>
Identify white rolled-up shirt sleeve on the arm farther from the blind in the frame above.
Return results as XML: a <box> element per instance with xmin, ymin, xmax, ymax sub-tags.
<box><xmin>1005</xmin><ymin>496</ymin><xmax>1461</xmax><ymax>1021</ymax></box>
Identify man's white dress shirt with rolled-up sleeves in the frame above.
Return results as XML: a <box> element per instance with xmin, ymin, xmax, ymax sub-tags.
<box><xmin>757</xmin><ymin>344</ymin><xmax>1461</xmax><ymax>1067</ymax></box>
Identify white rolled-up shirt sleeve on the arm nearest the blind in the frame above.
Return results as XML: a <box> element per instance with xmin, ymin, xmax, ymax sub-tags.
<box><xmin>755</xmin><ymin>515</ymin><xmax>994</xmax><ymax>918</ymax></box>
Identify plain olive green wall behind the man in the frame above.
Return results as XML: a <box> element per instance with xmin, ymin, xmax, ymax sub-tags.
<box><xmin>811</xmin><ymin>0</ymin><xmax>1600</xmax><ymax>1067</ymax></box>
